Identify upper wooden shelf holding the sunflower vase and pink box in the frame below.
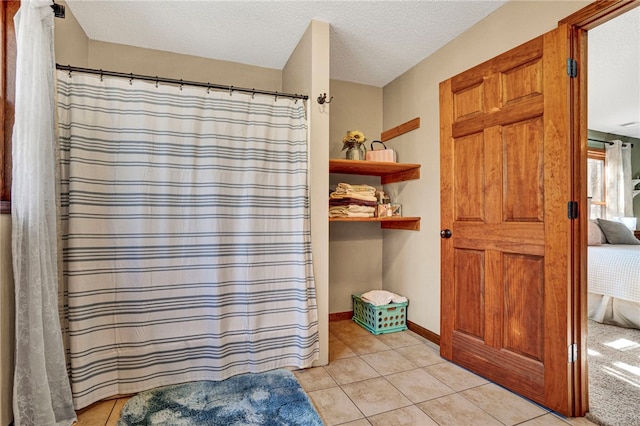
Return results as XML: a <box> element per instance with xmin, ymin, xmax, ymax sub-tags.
<box><xmin>329</xmin><ymin>159</ymin><xmax>420</xmax><ymax>185</ymax></box>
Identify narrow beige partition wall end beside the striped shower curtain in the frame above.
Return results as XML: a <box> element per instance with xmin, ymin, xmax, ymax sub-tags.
<box><xmin>282</xmin><ymin>21</ymin><xmax>329</xmax><ymax>365</ymax></box>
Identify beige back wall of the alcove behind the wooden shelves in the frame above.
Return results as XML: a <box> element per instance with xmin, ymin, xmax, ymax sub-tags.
<box><xmin>328</xmin><ymin>80</ymin><xmax>383</xmax><ymax>313</ymax></box>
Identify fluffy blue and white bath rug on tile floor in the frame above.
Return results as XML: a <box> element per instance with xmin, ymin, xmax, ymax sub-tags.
<box><xmin>118</xmin><ymin>369</ymin><xmax>323</xmax><ymax>426</ymax></box>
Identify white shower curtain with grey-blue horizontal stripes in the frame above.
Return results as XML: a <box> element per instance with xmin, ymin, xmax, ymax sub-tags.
<box><xmin>58</xmin><ymin>71</ymin><xmax>318</xmax><ymax>408</ymax></box>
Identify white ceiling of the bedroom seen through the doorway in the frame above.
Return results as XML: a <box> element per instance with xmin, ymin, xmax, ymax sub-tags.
<box><xmin>588</xmin><ymin>7</ymin><xmax>640</xmax><ymax>138</ymax></box>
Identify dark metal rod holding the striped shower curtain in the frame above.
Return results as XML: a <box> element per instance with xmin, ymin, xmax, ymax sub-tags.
<box><xmin>56</xmin><ymin>64</ymin><xmax>309</xmax><ymax>100</ymax></box>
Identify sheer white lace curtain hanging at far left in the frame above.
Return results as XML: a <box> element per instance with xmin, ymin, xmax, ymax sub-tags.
<box><xmin>11</xmin><ymin>0</ymin><xmax>76</xmax><ymax>426</ymax></box>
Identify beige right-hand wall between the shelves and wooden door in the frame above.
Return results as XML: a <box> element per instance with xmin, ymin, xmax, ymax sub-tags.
<box><xmin>383</xmin><ymin>1</ymin><xmax>590</xmax><ymax>333</ymax></box>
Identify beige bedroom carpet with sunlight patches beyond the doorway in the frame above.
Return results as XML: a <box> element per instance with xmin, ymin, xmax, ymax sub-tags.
<box><xmin>586</xmin><ymin>320</ymin><xmax>640</xmax><ymax>426</ymax></box>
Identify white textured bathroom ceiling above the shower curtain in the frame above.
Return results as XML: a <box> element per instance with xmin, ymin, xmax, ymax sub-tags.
<box><xmin>66</xmin><ymin>0</ymin><xmax>505</xmax><ymax>87</ymax></box>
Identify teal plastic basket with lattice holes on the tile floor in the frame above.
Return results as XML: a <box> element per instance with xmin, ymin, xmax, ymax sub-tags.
<box><xmin>352</xmin><ymin>294</ymin><xmax>409</xmax><ymax>334</ymax></box>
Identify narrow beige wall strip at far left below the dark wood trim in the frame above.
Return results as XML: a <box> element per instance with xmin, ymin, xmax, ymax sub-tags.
<box><xmin>0</xmin><ymin>214</ymin><xmax>15</xmax><ymax>425</ymax></box>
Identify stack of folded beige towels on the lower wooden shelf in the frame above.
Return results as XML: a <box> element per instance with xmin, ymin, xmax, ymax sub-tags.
<box><xmin>329</xmin><ymin>183</ymin><xmax>377</xmax><ymax>217</ymax></box>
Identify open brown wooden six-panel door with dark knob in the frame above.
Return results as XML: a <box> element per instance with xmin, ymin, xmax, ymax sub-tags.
<box><xmin>440</xmin><ymin>25</ymin><xmax>574</xmax><ymax>416</ymax></box>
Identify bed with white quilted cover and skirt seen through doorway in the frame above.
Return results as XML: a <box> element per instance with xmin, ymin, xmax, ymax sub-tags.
<box><xmin>587</xmin><ymin>221</ymin><xmax>640</xmax><ymax>329</ymax></box>
